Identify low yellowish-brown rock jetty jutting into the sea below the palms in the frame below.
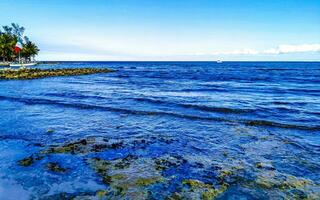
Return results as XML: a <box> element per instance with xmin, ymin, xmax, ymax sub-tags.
<box><xmin>0</xmin><ymin>68</ymin><xmax>115</xmax><ymax>80</ymax></box>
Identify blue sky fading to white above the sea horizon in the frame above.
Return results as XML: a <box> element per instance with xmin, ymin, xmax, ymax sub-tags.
<box><xmin>0</xmin><ymin>0</ymin><xmax>320</xmax><ymax>61</ymax></box>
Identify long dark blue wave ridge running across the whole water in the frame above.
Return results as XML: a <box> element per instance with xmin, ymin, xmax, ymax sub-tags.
<box><xmin>0</xmin><ymin>96</ymin><xmax>320</xmax><ymax>131</ymax></box>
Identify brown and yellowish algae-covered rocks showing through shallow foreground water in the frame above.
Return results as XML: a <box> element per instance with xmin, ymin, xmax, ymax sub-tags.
<box><xmin>17</xmin><ymin>136</ymin><xmax>319</xmax><ymax>200</ymax></box>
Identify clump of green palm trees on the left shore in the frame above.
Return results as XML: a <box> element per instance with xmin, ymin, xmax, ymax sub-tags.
<box><xmin>0</xmin><ymin>23</ymin><xmax>39</xmax><ymax>62</ymax></box>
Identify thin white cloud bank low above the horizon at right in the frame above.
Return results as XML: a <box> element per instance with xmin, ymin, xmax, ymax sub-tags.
<box><xmin>205</xmin><ymin>44</ymin><xmax>320</xmax><ymax>55</ymax></box>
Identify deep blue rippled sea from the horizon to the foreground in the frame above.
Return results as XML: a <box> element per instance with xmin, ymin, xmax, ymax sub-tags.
<box><xmin>0</xmin><ymin>62</ymin><xmax>320</xmax><ymax>199</ymax></box>
